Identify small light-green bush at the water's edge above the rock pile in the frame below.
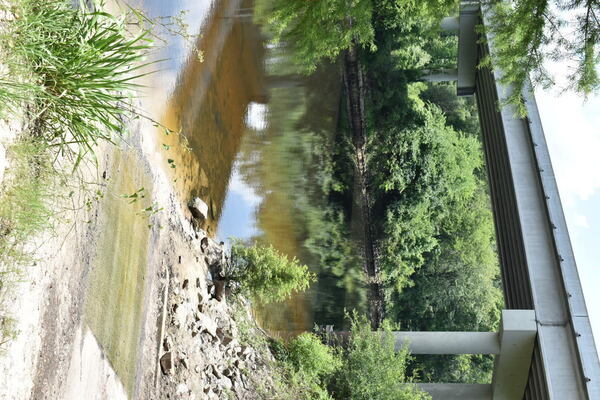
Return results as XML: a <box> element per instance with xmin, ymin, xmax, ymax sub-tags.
<box><xmin>226</xmin><ymin>242</ymin><xmax>315</xmax><ymax>303</ymax></box>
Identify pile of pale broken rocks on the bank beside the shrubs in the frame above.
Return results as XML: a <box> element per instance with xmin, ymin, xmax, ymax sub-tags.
<box><xmin>160</xmin><ymin>239</ymin><xmax>270</xmax><ymax>400</ymax></box>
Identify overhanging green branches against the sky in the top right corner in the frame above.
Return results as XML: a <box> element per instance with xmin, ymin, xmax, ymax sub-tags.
<box><xmin>487</xmin><ymin>0</ymin><xmax>600</xmax><ymax>115</ymax></box>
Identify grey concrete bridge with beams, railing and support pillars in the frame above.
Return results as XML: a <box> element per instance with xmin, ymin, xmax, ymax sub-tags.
<box><xmin>406</xmin><ymin>2</ymin><xmax>600</xmax><ymax>400</ymax></box>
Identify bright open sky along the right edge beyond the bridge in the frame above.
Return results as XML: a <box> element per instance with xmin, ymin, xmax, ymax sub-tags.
<box><xmin>536</xmin><ymin>79</ymin><xmax>600</xmax><ymax>346</ymax></box>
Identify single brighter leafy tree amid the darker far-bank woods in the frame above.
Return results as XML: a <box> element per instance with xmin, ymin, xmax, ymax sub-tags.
<box><xmin>371</xmin><ymin>101</ymin><xmax>481</xmax><ymax>291</ymax></box>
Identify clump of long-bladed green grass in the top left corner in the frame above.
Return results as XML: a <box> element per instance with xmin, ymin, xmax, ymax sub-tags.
<box><xmin>0</xmin><ymin>0</ymin><xmax>152</xmax><ymax>161</ymax></box>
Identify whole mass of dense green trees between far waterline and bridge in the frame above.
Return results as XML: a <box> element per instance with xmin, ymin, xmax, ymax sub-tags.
<box><xmin>364</xmin><ymin>12</ymin><xmax>502</xmax><ymax>383</ymax></box>
